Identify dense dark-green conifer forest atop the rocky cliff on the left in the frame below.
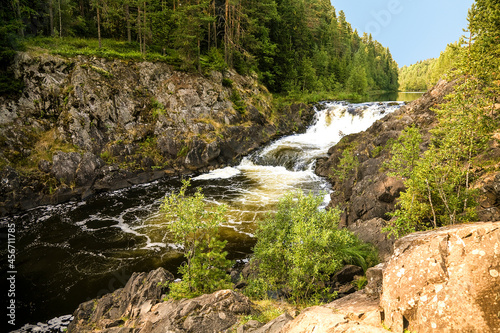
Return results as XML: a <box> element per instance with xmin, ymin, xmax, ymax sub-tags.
<box><xmin>0</xmin><ymin>0</ymin><xmax>398</xmax><ymax>94</ymax></box>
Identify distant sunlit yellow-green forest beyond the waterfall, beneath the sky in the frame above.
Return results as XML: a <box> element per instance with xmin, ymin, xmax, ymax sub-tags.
<box><xmin>399</xmin><ymin>40</ymin><xmax>464</xmax><ymax>91</ymax></box>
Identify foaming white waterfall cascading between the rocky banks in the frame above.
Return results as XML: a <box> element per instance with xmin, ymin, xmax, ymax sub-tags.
<box><xmin>194</xmin><ymin>102</ymin><xmax>400</xmax><ymax>231</ymax></box>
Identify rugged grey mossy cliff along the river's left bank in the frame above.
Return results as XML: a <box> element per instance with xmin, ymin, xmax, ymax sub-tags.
<box><xmin>0</xmin><ymin>50</ymin><xmax>313</xmax><ymax>215</ymax></box>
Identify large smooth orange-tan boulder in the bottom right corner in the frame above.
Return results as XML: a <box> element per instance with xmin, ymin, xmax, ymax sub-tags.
<box><xmin>381</xmin><ymin>222</ymin><xmax>500</xmax><ymax>333</ymax></box>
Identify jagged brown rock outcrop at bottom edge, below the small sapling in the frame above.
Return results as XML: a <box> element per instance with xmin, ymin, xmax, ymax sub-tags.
<box><xmin>68</xmin><ymin>268</ymin><xmax>254</xmax><ymax>333</ymax></box>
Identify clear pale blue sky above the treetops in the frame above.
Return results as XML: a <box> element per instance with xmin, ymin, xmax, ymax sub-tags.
<box><xmin>331</xmin><ymin>0</ymin><xmax>474</xmax><ymax>67</ymax></box>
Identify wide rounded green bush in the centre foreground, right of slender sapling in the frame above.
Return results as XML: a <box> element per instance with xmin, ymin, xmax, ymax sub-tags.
<box><xmin>251</xmin><ymin>191</ymin><xmax>376</xmax><ymax>302</ymax></box>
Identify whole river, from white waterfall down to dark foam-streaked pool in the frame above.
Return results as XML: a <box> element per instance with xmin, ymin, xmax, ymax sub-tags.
<box><xmin>0</xmin><ymin>94</ymin><xmax>420</xmax><ymax>332</ymax></box>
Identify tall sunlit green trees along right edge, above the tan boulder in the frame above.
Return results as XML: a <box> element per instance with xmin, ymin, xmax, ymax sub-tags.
<box><xmin>387</xmin><ymin>0</ymin><xmax>500</xmax><ymax>236</ymax></box>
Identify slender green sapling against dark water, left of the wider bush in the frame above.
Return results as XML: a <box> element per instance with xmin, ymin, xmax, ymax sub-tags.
<box><xmin>161</xmin><ymin>180</ymin><xmax>231</xmax><ymax>299</ymax></box>
